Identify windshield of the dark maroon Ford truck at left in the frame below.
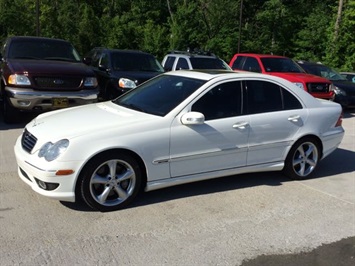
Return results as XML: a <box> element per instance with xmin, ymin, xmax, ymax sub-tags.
<box><xmin>8</xmin><ymin>39</ymin><xmax>80</xmax><ymax>62</ymax></box>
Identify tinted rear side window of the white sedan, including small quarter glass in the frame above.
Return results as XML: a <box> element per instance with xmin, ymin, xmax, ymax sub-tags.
<box><xmin>245</xmin><ymin>81</ymin><xmax>302</xmax><ymax>114</ymax></box>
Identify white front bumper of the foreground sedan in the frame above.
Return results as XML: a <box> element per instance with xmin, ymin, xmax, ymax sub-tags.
<box><xmin>14</xmin><ymin>136</ymin><xmax>82</xmax><ymax>202</ymax></box>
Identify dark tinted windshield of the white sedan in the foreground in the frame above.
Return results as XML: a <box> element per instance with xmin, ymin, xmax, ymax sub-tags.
<box><xmin>113</xmin><ymin>75</ymin><xmax>206</xmax><ymax>116</ymax></box>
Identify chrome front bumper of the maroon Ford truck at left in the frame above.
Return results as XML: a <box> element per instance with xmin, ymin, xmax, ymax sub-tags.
<box><xmin>5</xmin><ymin>86</ymin><xmax>99</xmax><ymax>111</ymax></box>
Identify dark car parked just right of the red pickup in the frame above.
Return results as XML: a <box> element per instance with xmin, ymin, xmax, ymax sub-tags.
<box><xmin>298</xmin><ymin>61</ymin><xmax>355</xmax><ymax>108</ymax></box>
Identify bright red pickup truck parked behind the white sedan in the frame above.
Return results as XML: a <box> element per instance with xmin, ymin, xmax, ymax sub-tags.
<box><xmin>229</xmin><ymin>54</ymin><xmax>334</xmax><ymax>100</ymax></box>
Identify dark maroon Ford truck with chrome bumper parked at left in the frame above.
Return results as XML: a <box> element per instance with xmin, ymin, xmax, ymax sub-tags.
<box><xmin>0</xmin><ymin>36</ymin><xmax>99</xmax><ymax>123</ymax></box>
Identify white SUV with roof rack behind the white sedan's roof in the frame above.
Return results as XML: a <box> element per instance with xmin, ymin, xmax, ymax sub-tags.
<box><xmin>162</xmin><ymin>50</ymin><xmax>231</xmax><ymax>71</ymax></box>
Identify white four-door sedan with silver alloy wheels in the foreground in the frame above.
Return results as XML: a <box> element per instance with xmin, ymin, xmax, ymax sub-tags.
<box><xmin>15</xmin><ymin>70</ymin><xmax>344</xmax><ymax>211</ymax></box>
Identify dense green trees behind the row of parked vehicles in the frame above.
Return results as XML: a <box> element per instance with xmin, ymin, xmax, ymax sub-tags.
<box><xmin>0</xmin><ymin>0</ymin><xmax>355</xmax><ymax>71</ymax></box>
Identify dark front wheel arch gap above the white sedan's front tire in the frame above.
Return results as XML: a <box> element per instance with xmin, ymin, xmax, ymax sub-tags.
<box><xmin>75</xmin><ymin>148</ymin><xmax>147</xmax><ymax>200</ymax></box>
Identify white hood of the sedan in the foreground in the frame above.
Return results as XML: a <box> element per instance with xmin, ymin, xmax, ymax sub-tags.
<box><xmin>26</xmin><ymin>101</ymin><xmax>158</xmax><ymax>141</ymax></box>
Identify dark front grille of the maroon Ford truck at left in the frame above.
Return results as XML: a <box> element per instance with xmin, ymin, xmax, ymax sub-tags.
<box><xmin>34</xmin><ymin>77</ymin><xmax>82</xmax><ymax>89</ymax></box>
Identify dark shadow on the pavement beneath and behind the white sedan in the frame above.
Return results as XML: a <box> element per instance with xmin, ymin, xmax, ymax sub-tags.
<box><xmin>62</xmin><ymin>149</ymin><xmax>355</xmax><ymax>212</ymax></box>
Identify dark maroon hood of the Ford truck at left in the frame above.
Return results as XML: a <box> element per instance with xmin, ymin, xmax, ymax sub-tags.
<box><xmin>7</xmin><ymin>59</ymin><xmax>94</xmax><ymax>76</ymax></box>
